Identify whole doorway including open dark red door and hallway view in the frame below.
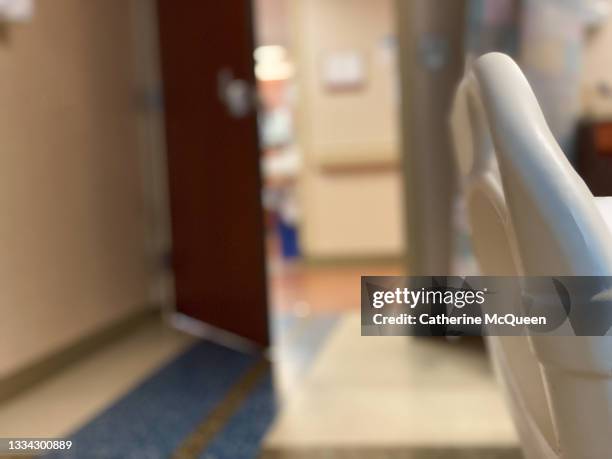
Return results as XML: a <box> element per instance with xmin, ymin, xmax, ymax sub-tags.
<box><xmin>158</xmin><ymin>0</ymin><xmax>405</xmax><ymax>396</ymax></box>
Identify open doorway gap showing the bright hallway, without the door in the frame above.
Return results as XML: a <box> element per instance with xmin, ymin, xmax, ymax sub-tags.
<box><xmin>254</xmin><ymin>0</ymin><xmax>405</xmax><ymax>396</ymax></box>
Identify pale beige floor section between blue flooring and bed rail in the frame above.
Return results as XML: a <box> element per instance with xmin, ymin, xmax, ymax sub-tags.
<box><xmin>263</xmin><ymin>314</ymin><xmax>520</xmax><ymax>459</ymax></box>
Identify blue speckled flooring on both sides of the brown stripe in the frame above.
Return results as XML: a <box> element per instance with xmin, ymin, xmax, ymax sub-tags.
<box><xmin>45</xmin><ymin>316</ymin><xmax>337</xmax><ymax>459</ymax></box>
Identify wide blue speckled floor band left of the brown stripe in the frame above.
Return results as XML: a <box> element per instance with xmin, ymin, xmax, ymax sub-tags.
<box><xmin>48</xmin><ymin>341</ymin><xmax>256</xmax><ymax>459</ymax></box>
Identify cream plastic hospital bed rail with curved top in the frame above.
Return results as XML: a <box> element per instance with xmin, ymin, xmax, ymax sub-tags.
<box><xmin>452</xmin><ymin>53</ymin><xmax>612</xmax><ymax>459</ymax></box>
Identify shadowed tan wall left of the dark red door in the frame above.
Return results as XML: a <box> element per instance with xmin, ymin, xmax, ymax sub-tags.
<box><xmin>0</xmin><ymin>0</ymin><xmax>155</xmax><ymax>377</ymax></box>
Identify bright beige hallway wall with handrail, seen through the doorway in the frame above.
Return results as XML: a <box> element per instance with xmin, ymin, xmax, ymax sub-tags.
<box><xmin>292</xmin><ymin>0</ymin><xmax>403</xmax><ymax>258</ymax></box>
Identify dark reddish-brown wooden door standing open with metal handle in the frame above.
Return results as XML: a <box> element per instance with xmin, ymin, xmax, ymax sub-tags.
<box><xmin>158</xmin><ymin>0</ymin><xmax>269</xmax><ymax>345</ymax></box>
